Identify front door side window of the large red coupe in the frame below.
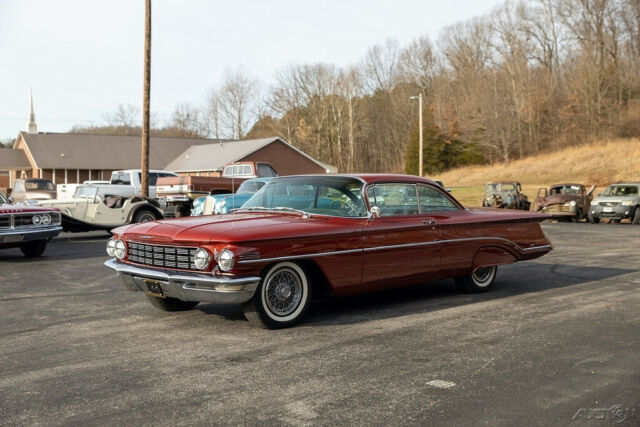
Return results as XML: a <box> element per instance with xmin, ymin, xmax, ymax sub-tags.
<box><xmin>367</xmin><ymin>184</ymin><xmax>420</xmax><ymax>217</ymax></box>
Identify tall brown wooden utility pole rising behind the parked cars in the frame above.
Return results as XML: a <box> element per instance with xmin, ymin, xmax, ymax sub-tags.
<box><xmin>140</xmin><ymin>0</ymin><xmax>151</xmax><ymax>197</ymax></box>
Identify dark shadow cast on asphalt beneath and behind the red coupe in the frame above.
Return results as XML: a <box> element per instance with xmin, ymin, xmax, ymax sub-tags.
<box><xmin>305</xmin><ymin>262</ymin><xmax>638</xmax><ymax>325</ymax></box>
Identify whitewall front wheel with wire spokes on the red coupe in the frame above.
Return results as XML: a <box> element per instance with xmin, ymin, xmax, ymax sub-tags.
<box><xmin>242</xmin><ymin>262</ymin><xmax>311</xmax><ymax>329</ymax></box>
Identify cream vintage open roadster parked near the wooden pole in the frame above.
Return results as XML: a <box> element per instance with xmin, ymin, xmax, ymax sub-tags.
<box><xmin>40</xmin><ymin>184</ymin><xmax>164</xmax><ymax>232</ymax></box>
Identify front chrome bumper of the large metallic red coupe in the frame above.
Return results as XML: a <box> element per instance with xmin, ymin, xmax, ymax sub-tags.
<box><xmin>104</xmin><ymin>259</ymin><xmax>261</xmax><ymax>304</ymax></box>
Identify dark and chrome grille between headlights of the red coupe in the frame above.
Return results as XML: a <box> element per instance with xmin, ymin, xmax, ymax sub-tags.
<box><xmin>127</xmin><ymin>242</ymin><xmax>198</xmax><ymax>270</ymax></box>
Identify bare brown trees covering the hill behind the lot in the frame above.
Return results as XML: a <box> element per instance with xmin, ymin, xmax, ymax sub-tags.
<box><xmin>75</xmin><ymin>0</ymin><xmax>640</xmax><ymax>174</ymax></box>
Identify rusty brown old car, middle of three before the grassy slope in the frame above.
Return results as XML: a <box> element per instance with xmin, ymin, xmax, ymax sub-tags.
<box><xmin>531</xmin><ymin>184</ymin><xmax>596</xmax><ymax>222</ymax></box>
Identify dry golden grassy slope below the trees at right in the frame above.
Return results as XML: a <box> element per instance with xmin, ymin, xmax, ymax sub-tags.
<box><xmin>434</xmin><ymin>139</ymin><xmax>640</xmax><ymax>206</ymax></box>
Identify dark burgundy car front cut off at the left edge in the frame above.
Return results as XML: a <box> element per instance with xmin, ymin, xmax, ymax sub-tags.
<box><xmin>0</xmin><ymin>193</ymin><xmax>62</xmax><ymax>257</ymax></box>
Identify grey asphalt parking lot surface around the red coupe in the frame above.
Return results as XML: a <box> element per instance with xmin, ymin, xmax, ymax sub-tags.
<box><xmin>0</xmin><ymin>223</ymin><xmax>640</xmax><ymax>425</ymax></box>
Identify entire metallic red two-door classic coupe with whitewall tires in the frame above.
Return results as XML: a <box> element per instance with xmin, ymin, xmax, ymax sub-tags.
<box><xmin>105</xmin><ymin>175</ymin><xmax>551</xmax><ymax>328</ymax></box>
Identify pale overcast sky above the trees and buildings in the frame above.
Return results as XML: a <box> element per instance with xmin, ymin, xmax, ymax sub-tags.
<box><xmin>0</xmin><ymin>0</ymin><xmax>502</xmax><ymax>140</ymax></box>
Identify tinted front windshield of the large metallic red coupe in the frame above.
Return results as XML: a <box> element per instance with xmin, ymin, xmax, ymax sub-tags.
<box><xmin>239</xmin><ymin>176</ymin><xmax>367</xmax><ymax>217</ymax></box>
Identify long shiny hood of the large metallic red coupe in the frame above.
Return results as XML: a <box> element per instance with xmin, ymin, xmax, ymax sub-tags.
<box><xmin>113</xmin><ymin>213</ymin><xmax>348</xmax><ymax>243</ymax></box>
